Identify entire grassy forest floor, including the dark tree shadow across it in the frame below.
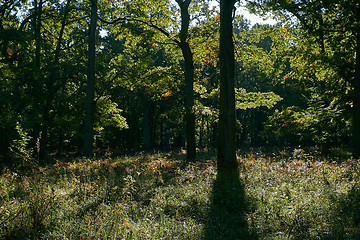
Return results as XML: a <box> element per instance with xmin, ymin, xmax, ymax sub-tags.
<box><xmin>0</xmin><ymin>149</ymin><xmax>360</xmax><ymax>239</ymax></box>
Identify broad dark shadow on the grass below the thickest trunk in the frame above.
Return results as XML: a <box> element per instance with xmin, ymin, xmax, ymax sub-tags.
<box><xmin>204</xmin><ymin>168</ymin><xmax>258</xmax><ymax>240</ymax></box>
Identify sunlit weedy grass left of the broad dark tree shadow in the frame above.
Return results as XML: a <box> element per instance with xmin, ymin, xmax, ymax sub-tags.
<box><xmin>0</xmin><ymin>154</ymin><xmax>215</xmax><ymax>239</ymax></box>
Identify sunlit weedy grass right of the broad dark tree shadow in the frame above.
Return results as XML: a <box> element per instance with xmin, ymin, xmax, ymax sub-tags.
<box><xmin>241</xmin><ymin>149</ymin><xmax>360</xmax><ymax>239</ymax></box>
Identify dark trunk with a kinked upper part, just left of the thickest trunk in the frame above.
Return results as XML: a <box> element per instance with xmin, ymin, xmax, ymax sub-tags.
<box><xmin>176</xmin><ymin>0</ymin><xmax>196</xmax><ymax>161</ymax></box>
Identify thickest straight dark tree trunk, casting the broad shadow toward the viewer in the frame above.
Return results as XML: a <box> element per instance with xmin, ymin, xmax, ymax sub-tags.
<box><xmin>218</xmin><ymin>0</ymin><xmax>237</xmax><ymax>168</ymax></box>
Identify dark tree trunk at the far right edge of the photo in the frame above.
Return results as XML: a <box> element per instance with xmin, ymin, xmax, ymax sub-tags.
<box><xmin>352</xmin><ymin>33</ymin><xmax>360</xmax><ymax>159</ymax></box>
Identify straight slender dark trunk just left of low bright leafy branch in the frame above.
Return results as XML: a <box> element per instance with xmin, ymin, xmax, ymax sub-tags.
<box><xmin>83</xmin><ymin>0</ymin><xmax>97</xmax><ymax>156</ymax></box>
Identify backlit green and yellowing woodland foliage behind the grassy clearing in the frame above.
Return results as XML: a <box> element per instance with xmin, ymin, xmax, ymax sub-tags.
<box><xmin>0</xmin><ymin>0</ymin><xmax>359</xmax><ymax>161</ymax></box>
